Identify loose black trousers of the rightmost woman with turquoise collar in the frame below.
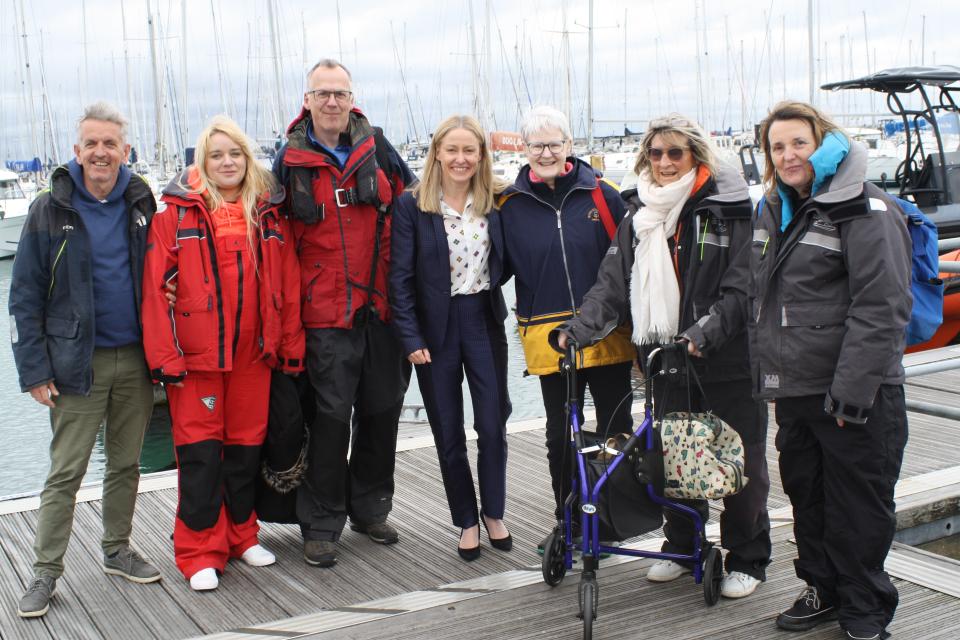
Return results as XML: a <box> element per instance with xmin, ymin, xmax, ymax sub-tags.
<box><xmin>776</xmin><ymin>385</ymin><xmax>907</xmax><ymax>633</ymax></box>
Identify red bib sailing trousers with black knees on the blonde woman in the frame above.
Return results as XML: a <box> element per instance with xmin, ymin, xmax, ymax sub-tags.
<box><xmin>167</xmin><ymin>227</ymin><xmax>270</xmax><ymax>578</ymax></box>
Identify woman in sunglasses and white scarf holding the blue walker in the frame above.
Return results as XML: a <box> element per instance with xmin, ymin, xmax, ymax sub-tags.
<box><xmin>551</xmin><ymin>114</ymin><xmax>771</xmax><ymax>598</ymax></box>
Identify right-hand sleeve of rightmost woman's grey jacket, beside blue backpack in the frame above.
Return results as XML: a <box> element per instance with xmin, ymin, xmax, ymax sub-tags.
<box><xmin>827</xmin><ymin>203</ymin><xmax>912</xmax><ymax>422</ymax></box>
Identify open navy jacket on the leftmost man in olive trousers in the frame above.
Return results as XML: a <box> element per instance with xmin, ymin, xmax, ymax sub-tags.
<box><xmin>9</xmin><ymin>166</ymin><xmax>157</xmax><ymax>396</ymax></box>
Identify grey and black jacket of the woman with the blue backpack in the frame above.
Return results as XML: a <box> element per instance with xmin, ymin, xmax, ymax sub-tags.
<box><xmin>749</xmin><ymin>144</ymin><xmax>912</xmax><ymax>423</ymax></box>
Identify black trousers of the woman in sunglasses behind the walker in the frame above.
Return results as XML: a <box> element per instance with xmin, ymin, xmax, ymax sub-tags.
<box><xmin>653</xmin><ymin>379</ymin><xmax>771</xmax><ymax>580</ymax></box>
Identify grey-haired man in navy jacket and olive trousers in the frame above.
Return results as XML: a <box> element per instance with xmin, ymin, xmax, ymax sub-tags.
<box><xmin>10</xmin><ymin>102</ymin><xmax>160</xmax><ymax>618</ymax></box>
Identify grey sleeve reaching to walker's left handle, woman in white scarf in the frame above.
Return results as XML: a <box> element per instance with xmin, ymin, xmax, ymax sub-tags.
<box><xmin>549</xmin><ymin>213</ymin><xmax>633</xmax><ymax>351</ymax></box>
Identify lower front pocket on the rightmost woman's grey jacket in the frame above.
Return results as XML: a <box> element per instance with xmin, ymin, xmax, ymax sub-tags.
<box><xmin>780</xmin><ymin>302</ymin><xmax>849</xmax><ymax>378</ymax></box>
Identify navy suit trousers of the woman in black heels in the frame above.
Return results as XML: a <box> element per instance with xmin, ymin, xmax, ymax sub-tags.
<box><xmin>417</xmin><ymin>291</ymin><xmax>511</xmax><ymax>529</ymax></box>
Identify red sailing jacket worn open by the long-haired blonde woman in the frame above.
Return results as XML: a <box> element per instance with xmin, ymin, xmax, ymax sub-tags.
<box><xmin>143</xmin><ymin>172</ymin><xmax>305</xmax><ymax>380</ymax></box>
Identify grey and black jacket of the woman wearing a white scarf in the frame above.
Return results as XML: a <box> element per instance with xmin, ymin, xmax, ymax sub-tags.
<box><xmin>551</xmin><ymin>164</ymin><xmax>752</xmax><ymax>382</ymax></box>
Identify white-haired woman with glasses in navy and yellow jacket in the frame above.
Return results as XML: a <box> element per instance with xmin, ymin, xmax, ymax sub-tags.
<box><xmin>500</xmin><ymin>106</ymin><xmax>636</xmax><ymax>553</ymax></box>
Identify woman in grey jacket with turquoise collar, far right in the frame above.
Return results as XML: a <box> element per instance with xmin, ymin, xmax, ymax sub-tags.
<box><xmin>750</xmin><ymin>102</ymin><xmax>911</xmax><ymax>639</ymax></box>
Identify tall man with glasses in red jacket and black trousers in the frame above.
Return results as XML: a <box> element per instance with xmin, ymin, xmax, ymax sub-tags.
<box><xmin>274</xmin><ymin>60</ymin><xmax>414</xmax><ymax>567</ymax></box>
